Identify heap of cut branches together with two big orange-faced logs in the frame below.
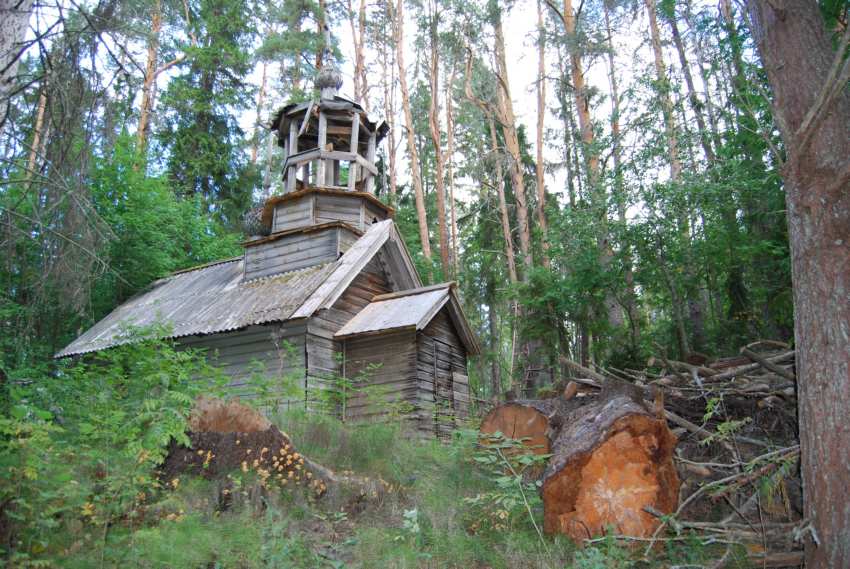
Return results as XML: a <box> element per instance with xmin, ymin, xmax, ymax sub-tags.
<box><xmin>481</xmin><ymin>341</ymin><xmax>804</xmax><ymax>566</ymax></box>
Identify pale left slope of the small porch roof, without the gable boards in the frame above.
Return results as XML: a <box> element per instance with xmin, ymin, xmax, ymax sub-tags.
<box><xmin>335</xmin><ymin>283</ymin><xmax>450</xmax><ymax>338</ymax></box>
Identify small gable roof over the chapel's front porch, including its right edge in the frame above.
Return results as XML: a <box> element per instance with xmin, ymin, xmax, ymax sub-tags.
<box><xmin>334</xmin><ymin>282</ymin><xmax>479</xmax><ymax>354</ymax></box>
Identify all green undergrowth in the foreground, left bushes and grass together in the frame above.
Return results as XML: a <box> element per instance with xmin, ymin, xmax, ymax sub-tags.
<box><xmin>0</xmin><ymin>341</ymin><xmax>760</xmax><ymax>568</ymax></box>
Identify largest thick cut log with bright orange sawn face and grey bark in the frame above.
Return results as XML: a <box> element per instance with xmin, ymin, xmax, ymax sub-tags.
<box><xmin>542</xmin><ymin>395</ymin><xmax>679</xmax><ymax>540</ymax></box>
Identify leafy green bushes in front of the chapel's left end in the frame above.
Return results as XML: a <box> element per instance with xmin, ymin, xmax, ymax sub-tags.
<box><xmin>0</xmin><ymin>332</ymin><xmax>221</xmax><ymax>565</ymax></box>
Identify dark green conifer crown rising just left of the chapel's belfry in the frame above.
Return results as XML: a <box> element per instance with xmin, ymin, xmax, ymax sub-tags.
<box><xmin>157</xmin><ymin>0</ymin><xmax>258</xmax><ymax>227</ymax></box>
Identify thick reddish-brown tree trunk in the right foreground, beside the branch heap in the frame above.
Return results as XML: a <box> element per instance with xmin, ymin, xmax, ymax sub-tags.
<box><xmin>747</xmin><ymin>0</ymin><xmax>850</xmax><ymax>568</ymax></box>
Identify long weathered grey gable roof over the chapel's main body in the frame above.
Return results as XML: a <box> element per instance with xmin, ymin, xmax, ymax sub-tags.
<box><xmin>55</xmin><ymin>220</ymin><xmax>421</xmax><ymax>358</ymax></box>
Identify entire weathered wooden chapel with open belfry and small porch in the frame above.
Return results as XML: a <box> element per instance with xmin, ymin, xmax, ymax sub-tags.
<box><xmin>57</xmin><ymin>61</ymin><xmax>479</xmax><ymax>436</ymax></box>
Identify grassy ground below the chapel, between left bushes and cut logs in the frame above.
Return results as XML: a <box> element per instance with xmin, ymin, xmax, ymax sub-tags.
<box><xmin>54</xmin><ymin>413</ymin><xmax>744</xmax><ymax>569</ymax></box>
